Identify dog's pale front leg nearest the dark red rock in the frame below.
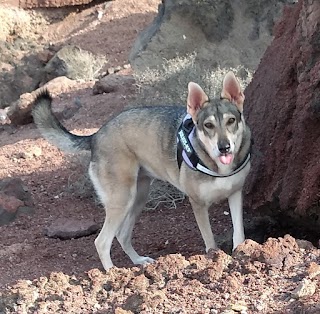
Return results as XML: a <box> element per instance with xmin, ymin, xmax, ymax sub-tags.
<box><xmin>228</xmin><ymin>190</ymin><xmax>245</xmax><ymax>250</ymax></box>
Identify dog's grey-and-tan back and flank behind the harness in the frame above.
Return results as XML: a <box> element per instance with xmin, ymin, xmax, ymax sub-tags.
<box><xmin>92</xmin><ymin>106</ymin><xmax>186</xmax><ymax>183</ymax></box>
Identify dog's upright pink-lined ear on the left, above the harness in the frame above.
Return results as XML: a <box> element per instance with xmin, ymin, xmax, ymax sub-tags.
<box><xmin>187</xmin><ymin>82</ymin><xmax>209</xmax><ymax>121</ymax></box>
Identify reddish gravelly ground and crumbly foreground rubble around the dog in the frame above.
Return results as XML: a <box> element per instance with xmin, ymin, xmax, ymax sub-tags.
<box><xmin>0</xmin><ymin>0</ymin><xmax>320</xmax><ymax>314</ymax></box>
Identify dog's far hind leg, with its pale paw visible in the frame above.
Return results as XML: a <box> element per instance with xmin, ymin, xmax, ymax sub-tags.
<box><xmin>117</xmin><ymin>173</ymin><xmax>154</xmax><ymax>264</ymax></box>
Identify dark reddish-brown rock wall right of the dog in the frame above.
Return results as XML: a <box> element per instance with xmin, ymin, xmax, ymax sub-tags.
<box><xmin>245</xmin><ymin>0</ymin><xmax>320</xmax><ymax>222</ymax></box>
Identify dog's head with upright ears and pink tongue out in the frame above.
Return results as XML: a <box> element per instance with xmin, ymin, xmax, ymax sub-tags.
<box><xmin>187</xmin><ymin>72</ymin><xmax>245</xmax><ymax>166</ymax></box>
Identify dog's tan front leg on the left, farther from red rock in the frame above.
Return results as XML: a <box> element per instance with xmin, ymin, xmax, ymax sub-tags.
<box><xmin>190</xmin><ymin>199</ymin><xmax>217</xmax><ymax>252</ymax></box>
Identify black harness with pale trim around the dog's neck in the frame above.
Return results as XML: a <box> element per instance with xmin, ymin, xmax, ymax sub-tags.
<box><xmin>177</xmin><ymin>114</ymin><xmax>250</xmax><ymax>178</ymax></box>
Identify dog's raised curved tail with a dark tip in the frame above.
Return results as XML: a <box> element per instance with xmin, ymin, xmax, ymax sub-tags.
<box><xmin>32</xmin><ymin>90</ymin><xmax>92</xmax><ymax>153</ymax></box>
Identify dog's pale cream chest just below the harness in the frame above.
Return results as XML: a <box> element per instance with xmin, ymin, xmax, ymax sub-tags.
<box><xmin>198</xmin><ymin>167</ymin><xmax>249</xmax><ymax>203</ymax></box>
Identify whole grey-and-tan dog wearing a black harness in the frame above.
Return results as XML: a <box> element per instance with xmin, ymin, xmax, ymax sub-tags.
<box><xmin>32</xmin><ymin>72</ymin><xmax>251</xmax><ymax>270</ymax></box>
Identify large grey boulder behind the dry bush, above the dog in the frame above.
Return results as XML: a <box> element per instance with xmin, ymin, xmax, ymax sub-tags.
<box><xmin>129</xmin><ymin>0</ymin><xmax>293</xmax><ymax>70</ymax></box>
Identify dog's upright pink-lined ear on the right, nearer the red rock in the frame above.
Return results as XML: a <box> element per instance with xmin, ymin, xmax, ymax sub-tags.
<box><xmin>221</xmin><ymin>71</ymin><xmax>244</xmax><ymax>112</ymax></box>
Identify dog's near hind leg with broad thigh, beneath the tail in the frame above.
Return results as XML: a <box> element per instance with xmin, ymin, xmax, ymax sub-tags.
<box><xmin>89</xmin><ymin>163</ymin><xmax>138</xmax><ymax>270</ymax></box>
